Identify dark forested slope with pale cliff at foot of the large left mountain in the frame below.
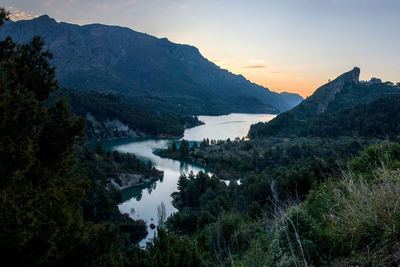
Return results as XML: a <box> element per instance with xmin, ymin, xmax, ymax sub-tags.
<box><xmin>48</xmin><ymin>88</ymin><xmax>201</xmax><ymax>139</ymax></box>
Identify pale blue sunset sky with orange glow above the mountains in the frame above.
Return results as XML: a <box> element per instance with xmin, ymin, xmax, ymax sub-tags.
<box><xmin>2</xmin><ymin>0</ymin><xmax>400</xmax><ymax>97</ymax></box>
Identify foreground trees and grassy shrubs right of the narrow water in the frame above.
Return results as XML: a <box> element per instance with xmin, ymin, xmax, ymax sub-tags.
<box><xmin>159</xmin><ymin>143</ymin><xmax>400</xmax><ymax>266</ymax></box>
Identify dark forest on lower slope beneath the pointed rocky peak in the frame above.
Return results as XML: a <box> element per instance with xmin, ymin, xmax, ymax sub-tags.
<box><xmin>249</xmin><ymin>95</ymin><xmax>400</xmax><ymax>139</ymax></box>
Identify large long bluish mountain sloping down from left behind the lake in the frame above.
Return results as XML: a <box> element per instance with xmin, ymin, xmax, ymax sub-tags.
<box><xmin>0</xmin><ymin>15</ymin><xmax>296</xmax><ymax>115</ymax></box>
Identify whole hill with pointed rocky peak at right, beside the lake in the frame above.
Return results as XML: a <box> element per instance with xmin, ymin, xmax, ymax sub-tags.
<box><xmin>249</xmin><ymin>68</ymin><xmax>400</xmax><ymax>138</ymax></box>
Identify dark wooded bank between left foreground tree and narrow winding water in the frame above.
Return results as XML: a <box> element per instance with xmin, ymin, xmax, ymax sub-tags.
<box><xmin>75</xmin><ymin>143</ymin><xmax>163</xmax><ymax>225</ymax></box>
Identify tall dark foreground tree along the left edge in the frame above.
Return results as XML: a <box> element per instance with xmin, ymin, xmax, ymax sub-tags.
<box><xmin>0</xmin><ymin>8</ymin><xmax>126</xmax><ymax>266</ymax></box>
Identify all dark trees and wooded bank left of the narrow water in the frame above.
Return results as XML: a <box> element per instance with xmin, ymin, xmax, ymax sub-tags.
<box><xmin>0</xmin><ymin>8</ymin><xmax>192</xmax><ymax>266</ymax></box>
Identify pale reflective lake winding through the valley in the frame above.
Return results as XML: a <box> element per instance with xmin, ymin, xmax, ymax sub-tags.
<box><xmin>105</xmin><ymin>114</ymin><xmax>275</xmax><ymax>245</ymax></box>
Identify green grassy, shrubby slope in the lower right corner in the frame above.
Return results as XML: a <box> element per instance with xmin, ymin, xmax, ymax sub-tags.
<box><xmin>244</xmin><ymin>144</ymin><xmax>400</xmax><ymax>266</ymax></box>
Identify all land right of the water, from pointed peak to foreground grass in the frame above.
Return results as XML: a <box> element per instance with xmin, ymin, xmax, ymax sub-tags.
<box><xmin>155</xmin><ymin>69</ymin><xmax>400</xmax><ymax>266</ymax></box>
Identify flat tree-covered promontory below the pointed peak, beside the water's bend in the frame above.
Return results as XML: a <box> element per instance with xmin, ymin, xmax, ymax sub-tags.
<box><xmin>157</xmin><ymin>137</ymin><xmax>382</xmax><ymax>180</ymax></box>
